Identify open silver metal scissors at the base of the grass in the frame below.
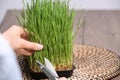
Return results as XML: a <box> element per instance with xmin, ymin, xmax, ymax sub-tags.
<box><xmin>36</xmin><ymin>58</ymin><xmax>59</xmax><ymax>80</ymax></box>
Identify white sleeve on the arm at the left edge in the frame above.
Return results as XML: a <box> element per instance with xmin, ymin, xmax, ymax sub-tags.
<box><xmin>0</xmin><ymin>34</ymin><xmax>22</xmax><ymax>80</ymax></box>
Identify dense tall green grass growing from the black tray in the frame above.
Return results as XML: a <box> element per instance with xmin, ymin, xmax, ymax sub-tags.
<box><xmin>19</xmin><ymin>0</ymin><xmax>78</xmax><ymax>77</ymax></box>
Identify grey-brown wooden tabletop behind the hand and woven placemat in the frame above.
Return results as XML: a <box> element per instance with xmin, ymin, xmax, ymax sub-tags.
<box><xmin>1</xmin><ymin>10</ymin><xmax>120</xmax><ymax>80</ymax></box>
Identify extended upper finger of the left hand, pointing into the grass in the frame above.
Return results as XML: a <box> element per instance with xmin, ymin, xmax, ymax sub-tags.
<box><xmin>20</xmin><ymin>39</ymin><xmax>43</xmax><ymax>50</ymax></box>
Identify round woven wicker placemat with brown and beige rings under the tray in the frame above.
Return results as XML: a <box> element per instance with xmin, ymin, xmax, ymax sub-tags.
<box><xmin>19</xmin><ymin>45</ymin><xmax>120</xmax><ymax>80</ymax></box>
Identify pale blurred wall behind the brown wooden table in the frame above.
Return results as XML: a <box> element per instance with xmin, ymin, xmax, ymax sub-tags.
<box><xmin>0</xmin><ymin>0</ymin><xmax>120</xmax><ymax>24</ymax></box>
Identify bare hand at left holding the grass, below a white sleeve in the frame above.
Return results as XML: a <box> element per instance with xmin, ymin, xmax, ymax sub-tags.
<box><xmin>3</xmin><ymin>25</ymin><xmax>43</xmax><ymax>56</ymax></box>
